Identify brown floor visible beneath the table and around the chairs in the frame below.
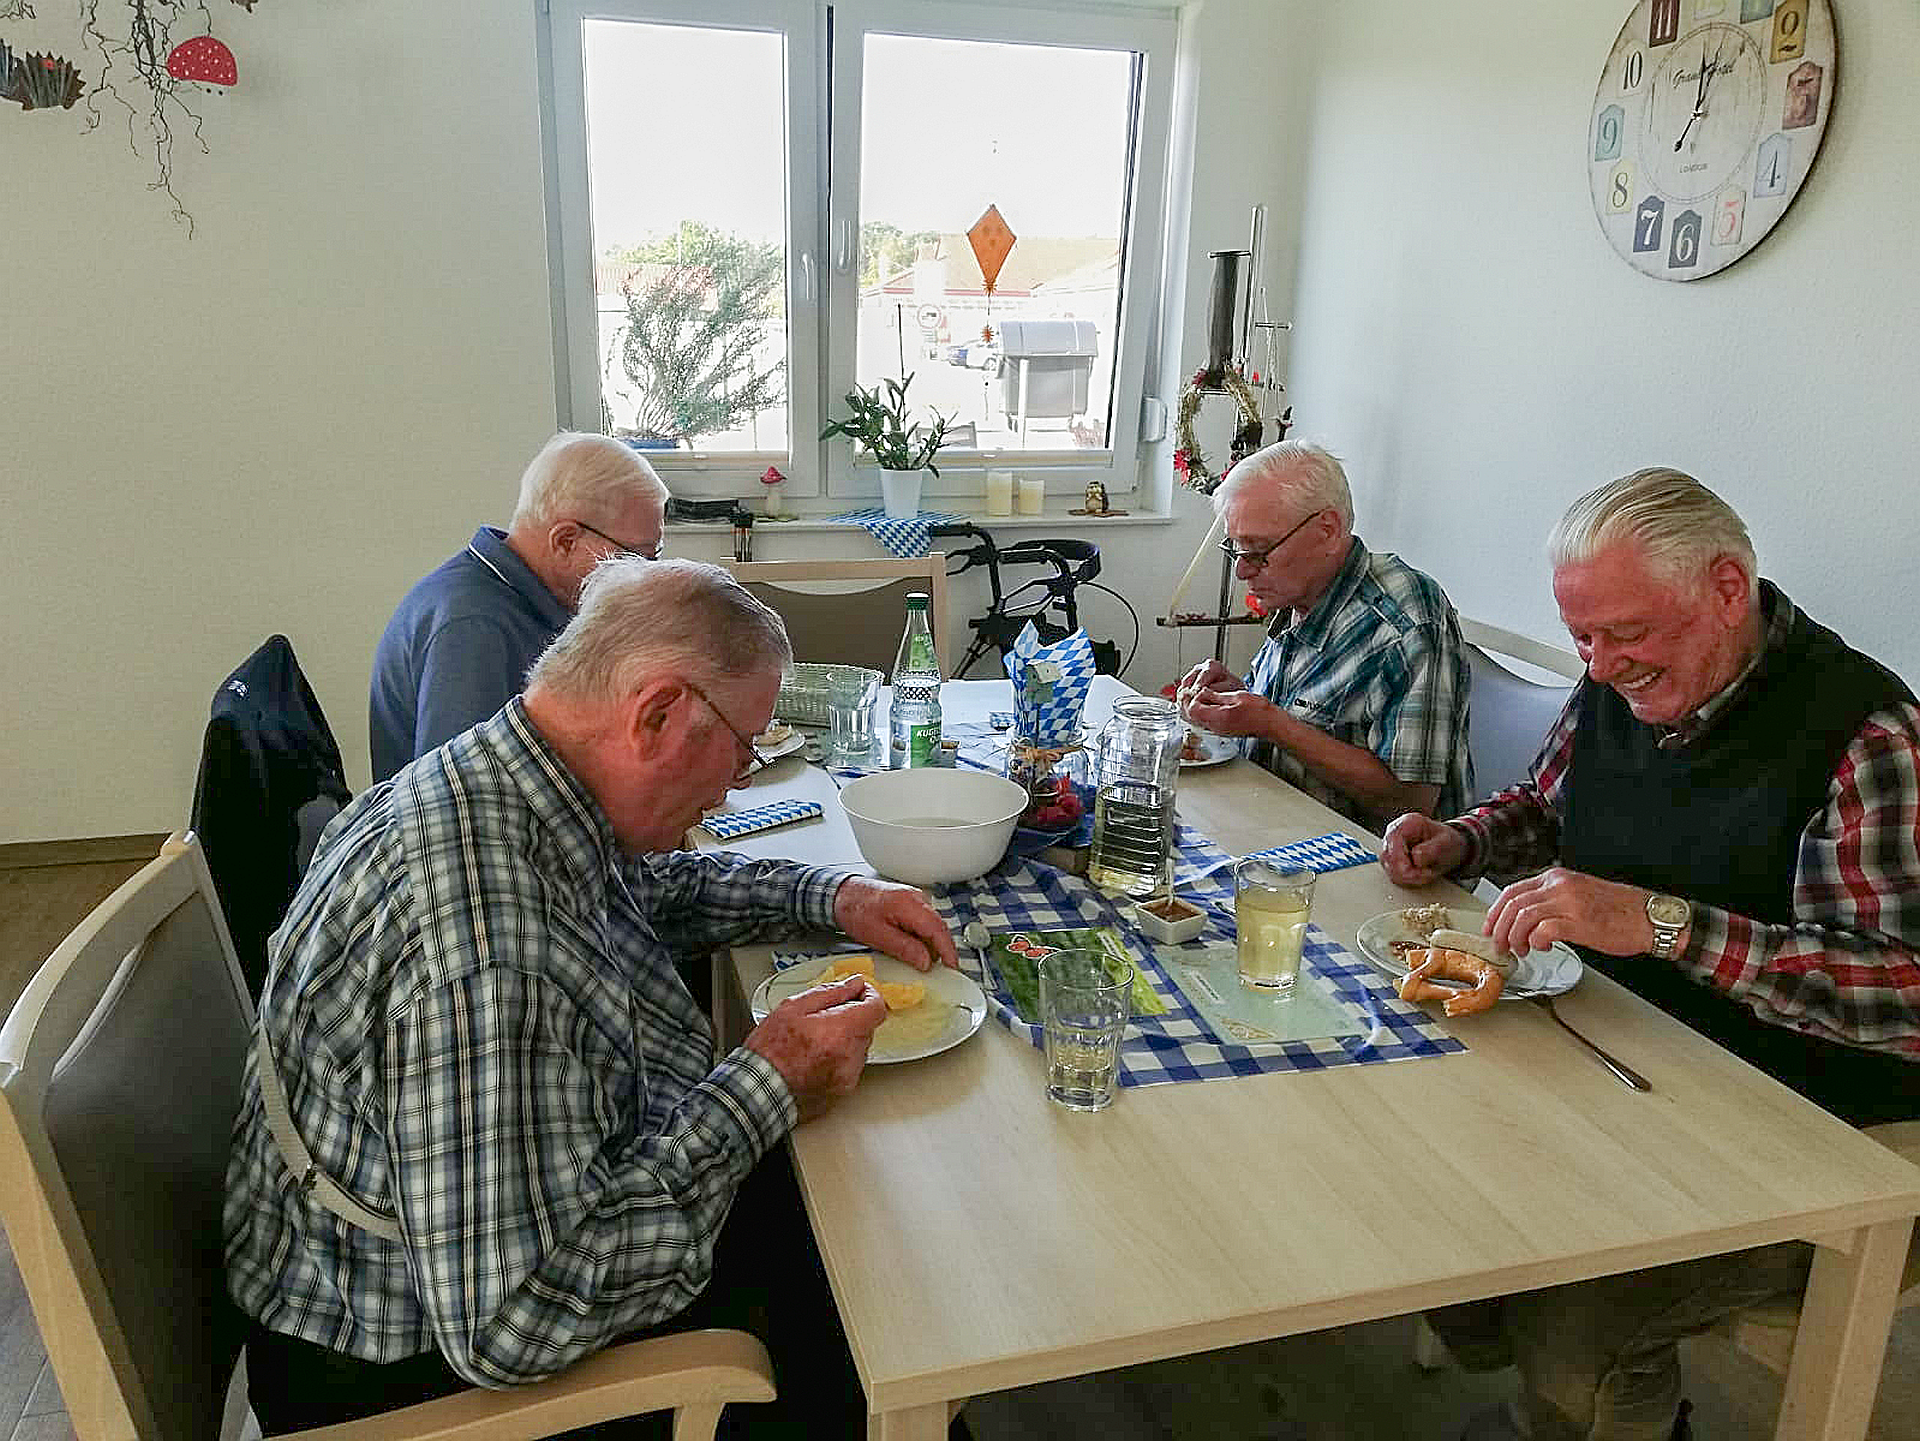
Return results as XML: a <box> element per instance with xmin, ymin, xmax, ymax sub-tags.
<box><xmin>0</xmin><ymin>862</ymin><xmax>1920</xmax><ymax>1441</ymax></box>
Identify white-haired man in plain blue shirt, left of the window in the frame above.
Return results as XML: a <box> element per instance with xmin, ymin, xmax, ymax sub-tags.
<box><xmin>367</xmin><ymin>432</ymin><xmax>666</xmax><ymax>781</ymax></box>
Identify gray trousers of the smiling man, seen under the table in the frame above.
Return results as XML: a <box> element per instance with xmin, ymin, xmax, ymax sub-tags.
<box><xmin>1427</xmin><ymin>1241</ymin><xmax>1812</xmax><ymax>1441</ymax></box>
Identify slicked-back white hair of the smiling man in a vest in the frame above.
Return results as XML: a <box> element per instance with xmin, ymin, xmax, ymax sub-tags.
<box><xmin>1548</xmin><ymin>466</ymin><xmax>1761</xmax><ymax>599</ymax></box>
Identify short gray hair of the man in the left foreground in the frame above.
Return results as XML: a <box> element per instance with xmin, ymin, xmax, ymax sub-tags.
<box><xmin>526</xmin><ymin>556</ymin><xmax>793</xmax><ymax>704</ymax></box>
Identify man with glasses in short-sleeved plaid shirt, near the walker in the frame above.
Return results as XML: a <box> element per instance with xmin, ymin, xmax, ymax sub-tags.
<box><xmin>1179</xmin><ymin>441</ymin><xmax>1473</xmax><ymax>829</ymax></box>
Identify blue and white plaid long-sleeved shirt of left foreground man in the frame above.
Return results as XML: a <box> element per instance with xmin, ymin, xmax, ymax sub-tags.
<box><xmin>225</xmin><ymin>698</ymin><xmax>845</xmax><ymax>1387</ymax></box>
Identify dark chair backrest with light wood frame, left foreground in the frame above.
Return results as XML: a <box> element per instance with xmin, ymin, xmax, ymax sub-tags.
<box><xmin>0</xmin><ymin>837</ymin><xmax>253</xmax><ymax>1441</ymax></box>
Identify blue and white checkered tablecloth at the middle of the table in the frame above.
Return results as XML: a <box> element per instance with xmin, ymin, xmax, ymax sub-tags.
<box><xmin>774</xmin><ymin>825</ymin><xmax>1467</xmax><ymax>1086</ymax></box>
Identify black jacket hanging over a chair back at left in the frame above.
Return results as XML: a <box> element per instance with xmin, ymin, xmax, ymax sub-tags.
<box><xmin>194</xmin><ymin>635</ymin><xmax>351</xmax><ymax>998</ymax></box>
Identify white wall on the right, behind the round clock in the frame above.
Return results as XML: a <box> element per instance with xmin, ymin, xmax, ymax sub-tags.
<box><xmin>1294</xmin><ymin>0</ymin><xmax>1920</xmax><ymax>683</ymax></box>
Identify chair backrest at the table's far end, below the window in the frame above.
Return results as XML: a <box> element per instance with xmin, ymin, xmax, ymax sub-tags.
<box><xmin>726</xmin><ymin>551</ymin><xmax>954</xmax><ymax>675</ymax></box>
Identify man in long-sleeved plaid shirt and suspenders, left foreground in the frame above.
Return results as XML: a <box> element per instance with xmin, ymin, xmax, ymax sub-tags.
<box><xmin>227</xmin><ymin>558</ymin><xmax>954</xmax><ymax>1435</ymax></box>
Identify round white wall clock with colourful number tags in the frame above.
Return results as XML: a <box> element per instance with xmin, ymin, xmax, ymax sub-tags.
<box><xmin>1586</xmin><ymin>0</ymin><xmax>1839</xmax><ymax>280</ymax></box>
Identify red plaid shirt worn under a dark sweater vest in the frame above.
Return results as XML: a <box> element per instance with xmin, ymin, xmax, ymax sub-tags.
<box><xmin>1452</xmin><ymin>595</ymin><xmax>1920</xmax><ymax>1061</ymax></box>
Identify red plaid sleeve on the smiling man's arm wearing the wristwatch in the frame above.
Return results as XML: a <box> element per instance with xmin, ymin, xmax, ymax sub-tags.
<box><xmin>1678</xmin><ymin>704</ymin><xmax>1920</xmax><ymax>1059</ymax></box>
